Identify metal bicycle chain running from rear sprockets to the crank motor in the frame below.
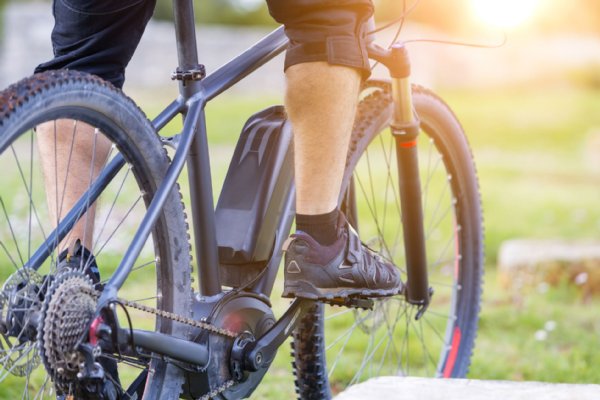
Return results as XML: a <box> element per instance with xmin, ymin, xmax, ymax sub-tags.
<box><xmin>81</xmin><ymin>287</ymin><xmax>238</xmax><ymax>400</ymax></box>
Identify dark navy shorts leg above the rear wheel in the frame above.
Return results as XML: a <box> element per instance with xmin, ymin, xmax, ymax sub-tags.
<box><xmin>36</xmin><ymin>0</ymin><xmax>156</xmax><ymax>87</ymax></box>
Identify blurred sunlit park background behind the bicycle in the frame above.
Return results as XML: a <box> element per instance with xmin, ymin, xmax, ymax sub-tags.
<box><xmin>0</xmin><ymin>0</ymin><xmax>600</xmax><ymax>398</ymax></box>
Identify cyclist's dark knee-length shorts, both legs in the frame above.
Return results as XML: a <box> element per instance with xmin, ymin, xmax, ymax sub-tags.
<box><xmin>36</xmin><ymin>0</ymin><xmax>373</xmax><ymax>87</ymax></box>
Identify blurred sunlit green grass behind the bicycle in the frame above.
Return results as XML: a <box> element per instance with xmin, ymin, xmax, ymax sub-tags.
<box><xmin>0</xmin><ymin>80</ymin><xmax>600</xmax><ymax>399</ymax></box>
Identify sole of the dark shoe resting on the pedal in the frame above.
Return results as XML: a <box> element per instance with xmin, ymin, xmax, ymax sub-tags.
<box><xmin>281</xmin><ymin>281</ymin><xmax>402</xmax><ymax>301</ymax></box>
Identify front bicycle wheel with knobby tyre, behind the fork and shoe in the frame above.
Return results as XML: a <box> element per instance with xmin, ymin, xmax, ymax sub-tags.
<box><xmin>292</xmin><ymin>81</ymin><xmax>483</xmax><ymax>399</ymax></box>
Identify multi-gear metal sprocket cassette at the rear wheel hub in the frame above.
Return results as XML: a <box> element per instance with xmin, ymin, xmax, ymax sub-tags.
<box><xmin>37</xmin><ymin>270</ymin><xmax>97</xmax><ymax>391</ymax></box>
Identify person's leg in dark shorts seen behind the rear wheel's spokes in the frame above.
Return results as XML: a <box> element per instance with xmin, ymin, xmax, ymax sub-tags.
<box><xmin>36</xmin><ymin>0</ymin><xmax>156</xmax><ymax>250</ymax></box>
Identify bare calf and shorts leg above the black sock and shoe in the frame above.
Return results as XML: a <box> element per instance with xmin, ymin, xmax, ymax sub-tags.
<box><xmin>268</xmin><ymin>0</ymin><xmax>372</xmax><ymax>219</ymax></box>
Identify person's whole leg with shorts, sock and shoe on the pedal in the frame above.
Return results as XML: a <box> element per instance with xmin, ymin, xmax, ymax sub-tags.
<box><xmin>269</xmin><ymin>0</ymin><xmax>401</xmax><ymax>299</ymax></box>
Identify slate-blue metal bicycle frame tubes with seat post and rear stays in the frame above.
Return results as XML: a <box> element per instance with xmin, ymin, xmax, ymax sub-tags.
<box><xmin>26</xmin><ymin>0</ymin><xmax>293</xmax><ymax>307</ymax></box>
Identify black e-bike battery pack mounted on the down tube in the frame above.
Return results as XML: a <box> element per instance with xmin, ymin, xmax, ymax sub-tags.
<box><xmin>216</xmin><ymin>106</ymin><xmax>293</xmax><ymax>287</ymax></box>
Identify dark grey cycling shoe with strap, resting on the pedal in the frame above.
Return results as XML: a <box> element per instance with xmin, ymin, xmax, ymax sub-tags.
<box><xmin>283</xmin><ymin>216</ymin><xmax>403</xmax><ymax>300</ymax></box>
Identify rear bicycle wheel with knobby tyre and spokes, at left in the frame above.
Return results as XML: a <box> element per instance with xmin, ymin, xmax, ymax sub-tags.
<box><xmin>0</xmin><ymin>71</ymin><xmax>191</xmax><ymax>399</ymax></box>
